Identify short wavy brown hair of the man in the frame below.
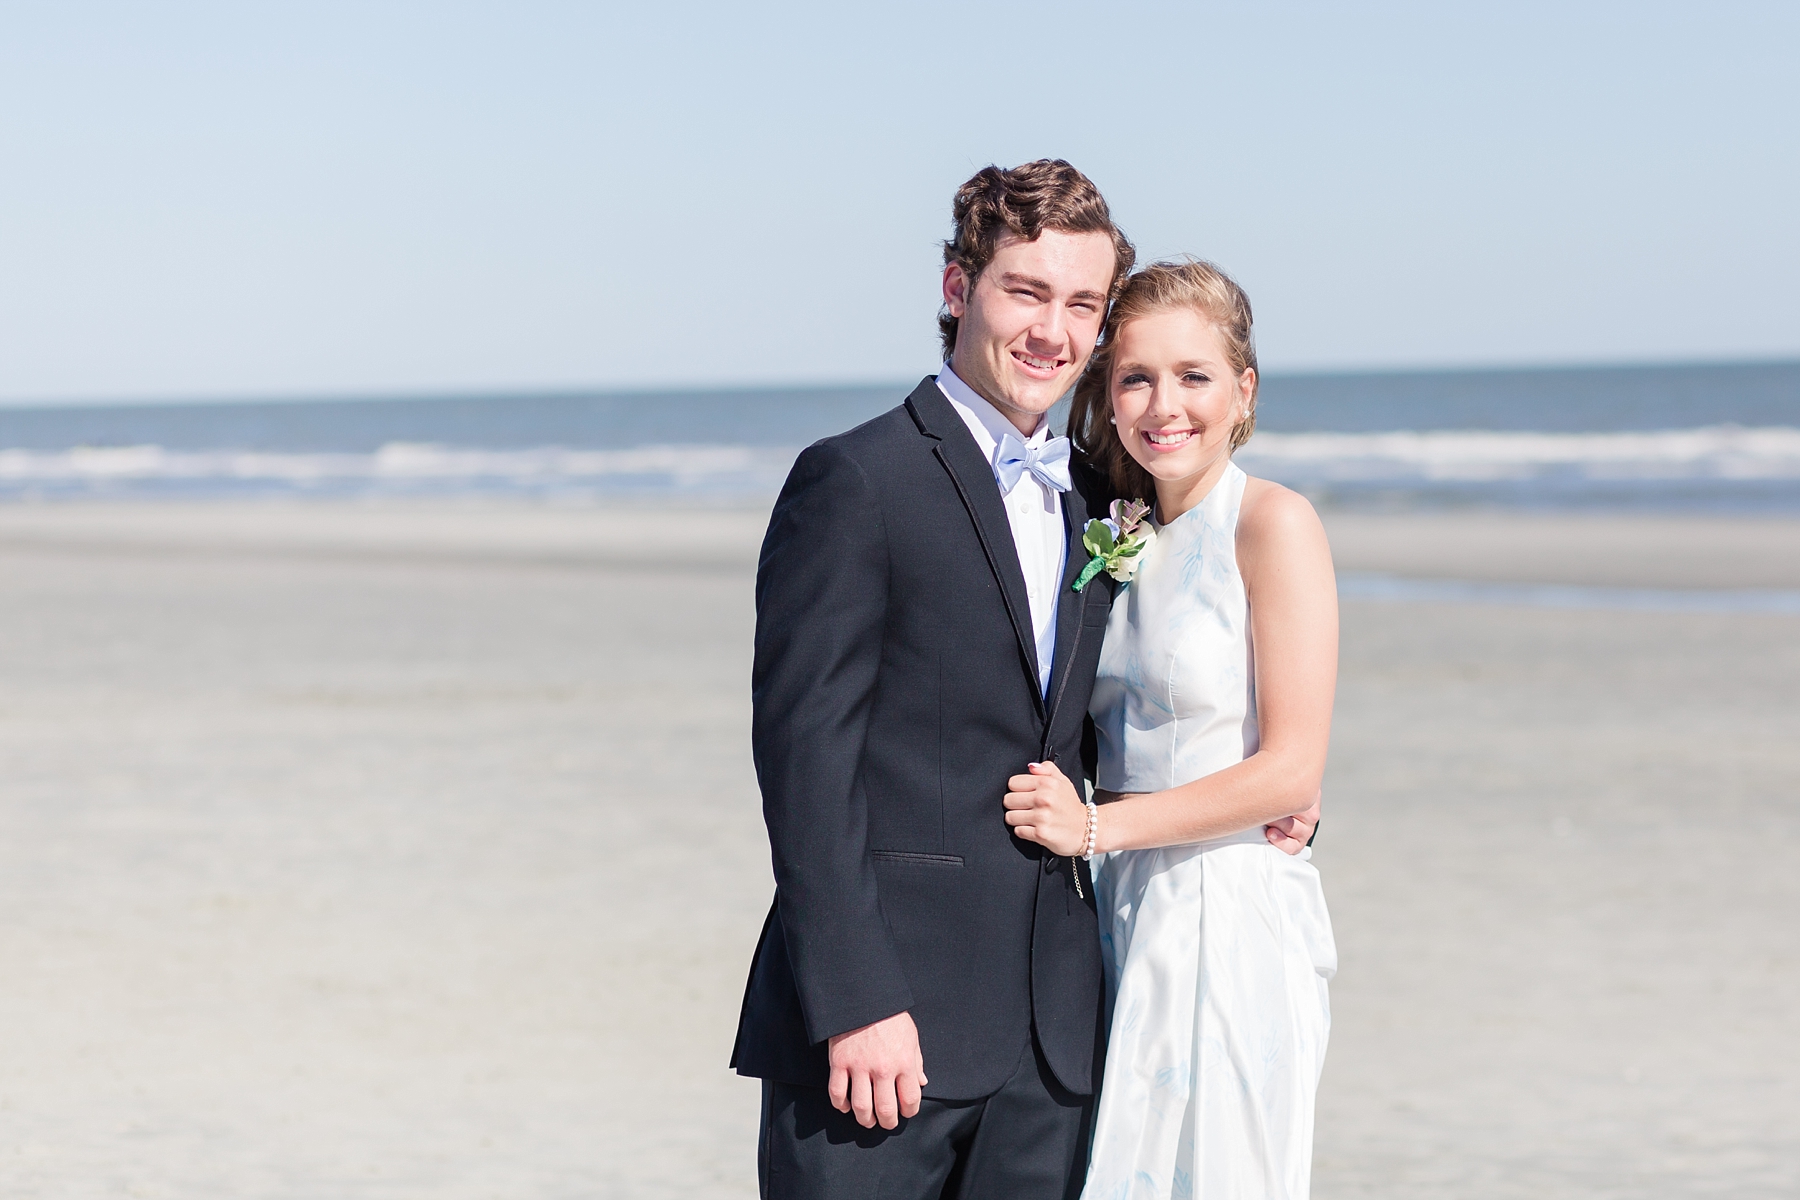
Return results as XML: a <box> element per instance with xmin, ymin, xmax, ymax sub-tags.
<box><xmin>938</xmin><ymin>158</ymin><xmax>1138</xmax><ymax>358</ymax></box>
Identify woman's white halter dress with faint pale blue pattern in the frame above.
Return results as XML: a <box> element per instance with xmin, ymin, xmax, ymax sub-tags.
<box><xmin>1082</xmin><ymin>464</ymin><xmax>1337</xmax><ymax>1200</ymax></box>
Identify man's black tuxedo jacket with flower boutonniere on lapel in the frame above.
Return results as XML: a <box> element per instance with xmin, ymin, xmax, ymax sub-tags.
<box><xmin>731</xmin><ymin>378</ymin><xmax>1114</xmax><ymax>1099</ymax></box>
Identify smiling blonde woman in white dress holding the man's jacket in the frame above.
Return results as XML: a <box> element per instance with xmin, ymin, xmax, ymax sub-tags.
<box><xmin>1006</xmin><ymin>263</ymin><xmax>1337</xmax><ymax>1200</ymax></box>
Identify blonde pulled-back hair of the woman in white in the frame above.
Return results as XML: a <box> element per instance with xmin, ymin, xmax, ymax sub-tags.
<box><xmin>1069</xmin><ymin>259</ymin><xmax>1262</xmax><ymax>500</ymax></box>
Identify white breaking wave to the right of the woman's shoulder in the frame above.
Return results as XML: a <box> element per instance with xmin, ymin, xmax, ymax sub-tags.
<box><xmin>1237</xmin><ymin>425</ymin><xmax>1800</xmax><ymax>482</ymax></box>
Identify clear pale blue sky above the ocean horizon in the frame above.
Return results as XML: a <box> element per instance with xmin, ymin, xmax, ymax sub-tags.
<box><xmin>0</xmin><ymin>0</ymin><xmax>1800</xmax><ymax>403</ymax></box>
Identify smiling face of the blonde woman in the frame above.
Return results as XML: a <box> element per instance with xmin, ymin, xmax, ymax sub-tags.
<box><xmin>1109</xmin><ymin>308</ymin><xmax>1256</xmax><ymax>503</ymax></box>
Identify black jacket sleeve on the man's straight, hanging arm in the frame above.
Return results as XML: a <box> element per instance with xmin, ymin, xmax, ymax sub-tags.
<box><xmin>751</xmin><ymin>443</ymin><xmax>913</xmax><ymax>1043</ymax></box>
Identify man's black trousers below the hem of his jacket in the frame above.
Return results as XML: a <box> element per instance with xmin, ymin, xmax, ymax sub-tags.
<box><xmin>756</xmin><ymin>1038</ymin><xmax>1094</xmax><ymax>1200</ymax></box>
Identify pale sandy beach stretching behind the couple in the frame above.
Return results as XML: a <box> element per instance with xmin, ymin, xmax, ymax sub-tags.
<box><xmin>0</xmin><ymin>502</ymin><xmax>1800</xmax><ymax>1200</ymax></box>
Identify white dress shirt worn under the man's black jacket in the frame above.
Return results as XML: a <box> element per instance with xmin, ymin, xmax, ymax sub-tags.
<box><xmin>938</xmin><ymin>363</ymin><xmax>1069</xmax><ymax>694</ymax></box>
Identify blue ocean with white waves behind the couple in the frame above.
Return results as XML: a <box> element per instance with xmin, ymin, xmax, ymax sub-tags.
<box><xmin>0</xmin><ymin>362</ymin><xmax>1800</xmax><ymax>513</ymax></box>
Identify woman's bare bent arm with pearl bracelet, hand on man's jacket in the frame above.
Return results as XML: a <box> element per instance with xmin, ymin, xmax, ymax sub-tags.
<box><xmin>1006</xmin><ymin>479</ymin><xmax>1337</xmax><ymax>855</ymax></box>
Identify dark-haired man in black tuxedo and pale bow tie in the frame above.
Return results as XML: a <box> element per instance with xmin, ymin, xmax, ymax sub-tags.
<box><xmin>733</xmin><ymin>160</ymin><xmax>1324</xmax><ymax>1200</ymax></box>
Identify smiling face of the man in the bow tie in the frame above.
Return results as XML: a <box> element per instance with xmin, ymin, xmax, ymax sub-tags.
<box><xmin>943</xmin><ymin>230</ymin><xmax>1116</xmax><ymax>435</ymax></box>
